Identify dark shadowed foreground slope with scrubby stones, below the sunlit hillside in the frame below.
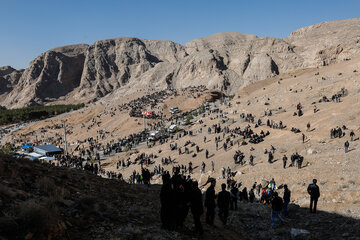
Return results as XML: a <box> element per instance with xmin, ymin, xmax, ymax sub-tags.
<box><xmin>0</xmin><ymin>155</ymin><xmax>360</xmax><ymax>239</ymax></box>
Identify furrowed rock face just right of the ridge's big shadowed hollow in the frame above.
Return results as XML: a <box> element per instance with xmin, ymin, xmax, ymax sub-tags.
<box><xmin>77</xmin><ymin>38</ymin><xmax>186</xmax><ymax>98</ymax></box>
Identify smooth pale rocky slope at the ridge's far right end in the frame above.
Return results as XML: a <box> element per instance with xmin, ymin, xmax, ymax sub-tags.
<box><xmin>284</xmin><ymin>18</ymin><xmax>360</xmax><ymax>67</ymax></box>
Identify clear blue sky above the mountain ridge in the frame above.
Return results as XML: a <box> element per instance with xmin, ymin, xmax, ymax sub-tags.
<box><xmin>0</xmin><ymin>0</ymin><xmax>360</xmax><ymax>69</ymax></box>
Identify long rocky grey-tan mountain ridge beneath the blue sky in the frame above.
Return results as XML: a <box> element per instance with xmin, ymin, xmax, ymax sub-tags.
<box><xmin>0</xmin><ymin>19</ymin><xmax>360</xmax><ymax>108</ymax></box>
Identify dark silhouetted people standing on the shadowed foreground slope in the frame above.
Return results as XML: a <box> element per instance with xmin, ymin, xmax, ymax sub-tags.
<box><xmin>160</xmin><ymin>173</ymin><xmax>320</xmax><ymax>235</ymax></box>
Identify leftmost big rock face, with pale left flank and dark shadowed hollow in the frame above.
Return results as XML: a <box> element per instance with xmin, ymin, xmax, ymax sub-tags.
<box><xmin>3</xmin><ymin>44</ymin><xmax>88</xmax><ymax>108</ymax></box>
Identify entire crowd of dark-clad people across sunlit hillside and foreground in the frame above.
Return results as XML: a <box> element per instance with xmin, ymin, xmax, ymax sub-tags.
<box><xmin>1</xmin><ymin>74</ymin><xmax>355</xmax><ymax>239</ymax></box>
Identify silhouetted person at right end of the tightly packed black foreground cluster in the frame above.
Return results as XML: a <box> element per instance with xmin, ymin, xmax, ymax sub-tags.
<box><xmin>190</xmin><ymin>181</ymin><xmax>204</xmax><ymax>235</ymax></box>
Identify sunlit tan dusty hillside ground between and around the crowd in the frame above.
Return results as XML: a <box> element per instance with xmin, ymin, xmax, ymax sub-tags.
<box><xmin>4</xmin><ymin>59</ymin><xmax>360</xmax><ymax>219</ymax></box>
